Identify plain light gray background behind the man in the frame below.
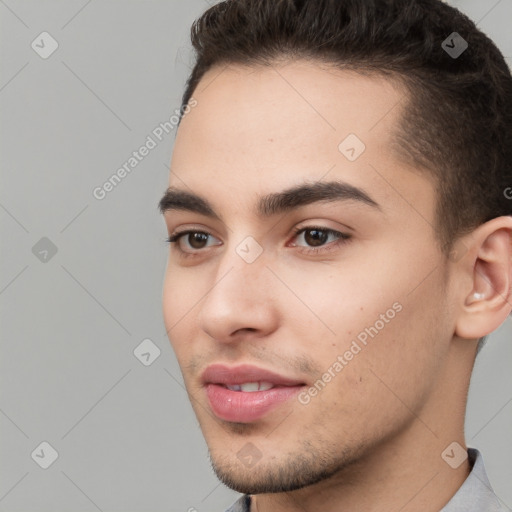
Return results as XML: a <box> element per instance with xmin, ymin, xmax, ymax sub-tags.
<box><xmin>0</xmin><ymin>0</ymin><xmax>512</xmax><ymax>512</ymax></box>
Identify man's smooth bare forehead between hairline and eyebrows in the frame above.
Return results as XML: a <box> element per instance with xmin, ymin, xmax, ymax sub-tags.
<box><xmin>169</xmin><ymin>61</ymin><xmax>433</xmax><ymax>223</ymax></box>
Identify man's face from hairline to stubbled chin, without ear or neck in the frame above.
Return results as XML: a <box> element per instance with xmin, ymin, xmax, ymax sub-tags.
<box><xmin>163</xmin><ymin>62</ymin><xmax>453</xmax><ymax>493</ymax></box>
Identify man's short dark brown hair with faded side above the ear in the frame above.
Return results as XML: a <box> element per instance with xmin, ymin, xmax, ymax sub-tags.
<box><xmin>182</xmin><ymin>0</ymin><xmax>512</xmax><ymax>255</ymax></box>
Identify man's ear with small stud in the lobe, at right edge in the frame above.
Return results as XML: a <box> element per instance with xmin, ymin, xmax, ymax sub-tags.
<box><xmin>455</xmin><ymin>216</ymin><xmax>512</xmax><ymax>339</ymax></box>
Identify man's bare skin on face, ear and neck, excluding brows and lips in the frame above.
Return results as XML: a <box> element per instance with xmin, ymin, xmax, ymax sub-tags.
<box><xmin>163</xmin><ymin>61</ymin><xmax>512</xmax><ymax>512</ymax></box>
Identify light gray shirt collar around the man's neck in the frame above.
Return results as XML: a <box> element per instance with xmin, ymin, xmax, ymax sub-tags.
<box><xmin>226</xmin><ymin>448</ymin><xmax>511</xmax><ymax>512</ymax></box>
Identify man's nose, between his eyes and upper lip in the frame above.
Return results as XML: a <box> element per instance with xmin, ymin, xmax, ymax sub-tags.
<box><xmin>198</xmin><ymin>243</ymin><xmax>278</xmax><ymax>343</ymax></box>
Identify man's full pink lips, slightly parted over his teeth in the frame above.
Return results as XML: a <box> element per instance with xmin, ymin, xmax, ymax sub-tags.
<box><xmin>201</xmin><ymin>364</ymin><xmax>305</xmax><ymax>423</ymax></box>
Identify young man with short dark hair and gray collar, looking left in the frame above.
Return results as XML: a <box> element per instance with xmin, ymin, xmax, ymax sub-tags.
<box><xmin>159</xmin><ymin>0</ymin><xmax>512</xmax><ymax>512</ymax></box>
